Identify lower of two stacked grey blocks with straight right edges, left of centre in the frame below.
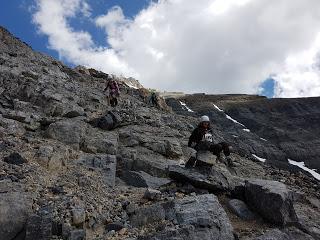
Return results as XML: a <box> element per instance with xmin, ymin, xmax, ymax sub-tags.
<box><xmin>76</xmin><ymin>154</ymin><xmax>117</xmax><ymax>187</ymax></box>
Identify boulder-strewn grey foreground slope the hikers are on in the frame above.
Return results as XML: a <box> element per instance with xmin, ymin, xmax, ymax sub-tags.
<box><xmin>0</xmin><ymin>25</ymin><xmax>320</xmax><ymax>240</ymax></box>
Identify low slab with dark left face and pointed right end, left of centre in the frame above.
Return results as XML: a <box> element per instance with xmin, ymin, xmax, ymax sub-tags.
<box><xmin>122</xmin><ymin>171</ymin><xmax>171</xmax><ymax>189</ymax></box>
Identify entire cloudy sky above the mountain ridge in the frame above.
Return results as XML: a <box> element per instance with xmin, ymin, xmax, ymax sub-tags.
<box><xmin>0</xmin><ymin>0</ymin><xmax>320</xmax><ymax>98</ymax></box>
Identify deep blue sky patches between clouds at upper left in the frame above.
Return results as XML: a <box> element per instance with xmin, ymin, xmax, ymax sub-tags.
<box><xmin>0</xmin><ymin>0</ymin><xmax>150</xmax><ymax>62</ymax></box>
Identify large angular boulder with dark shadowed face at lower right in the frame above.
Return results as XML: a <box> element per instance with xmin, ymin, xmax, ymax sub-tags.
<box><xmin>245</xmin><ymin>179</ymin><xmax>296</xmax><ymax>226</ymax></box>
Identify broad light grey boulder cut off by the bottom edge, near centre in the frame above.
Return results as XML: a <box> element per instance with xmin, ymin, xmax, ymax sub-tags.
<box><xmin>141</xmin><ymin>194</ymin><xmax>234</xmax><ymax>240</ymax></box>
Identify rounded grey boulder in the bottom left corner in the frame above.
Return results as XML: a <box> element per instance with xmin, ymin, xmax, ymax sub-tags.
<box><xmin>0</xmin><ymin>192</ymin><xmax>32</xmax><ymax>240</ymax></box>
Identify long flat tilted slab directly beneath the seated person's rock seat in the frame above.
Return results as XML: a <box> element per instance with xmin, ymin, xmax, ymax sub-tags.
<box><xmin>169</xmin><ymin>166</ymin><xmax>233</xmax><ymax>191</ymax></box>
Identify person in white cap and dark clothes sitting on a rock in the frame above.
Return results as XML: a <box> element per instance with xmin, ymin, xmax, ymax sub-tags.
<box><xmin>188</xmin><ymin>116</ymin><xmax>232</xmax><ymax>166</ymax></box>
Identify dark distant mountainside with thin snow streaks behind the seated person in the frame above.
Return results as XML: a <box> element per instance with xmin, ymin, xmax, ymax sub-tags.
<box><xmin>167</xmin><ymin>94</ymin><xmax>320</xmax><ymax>171</ymax></box>
